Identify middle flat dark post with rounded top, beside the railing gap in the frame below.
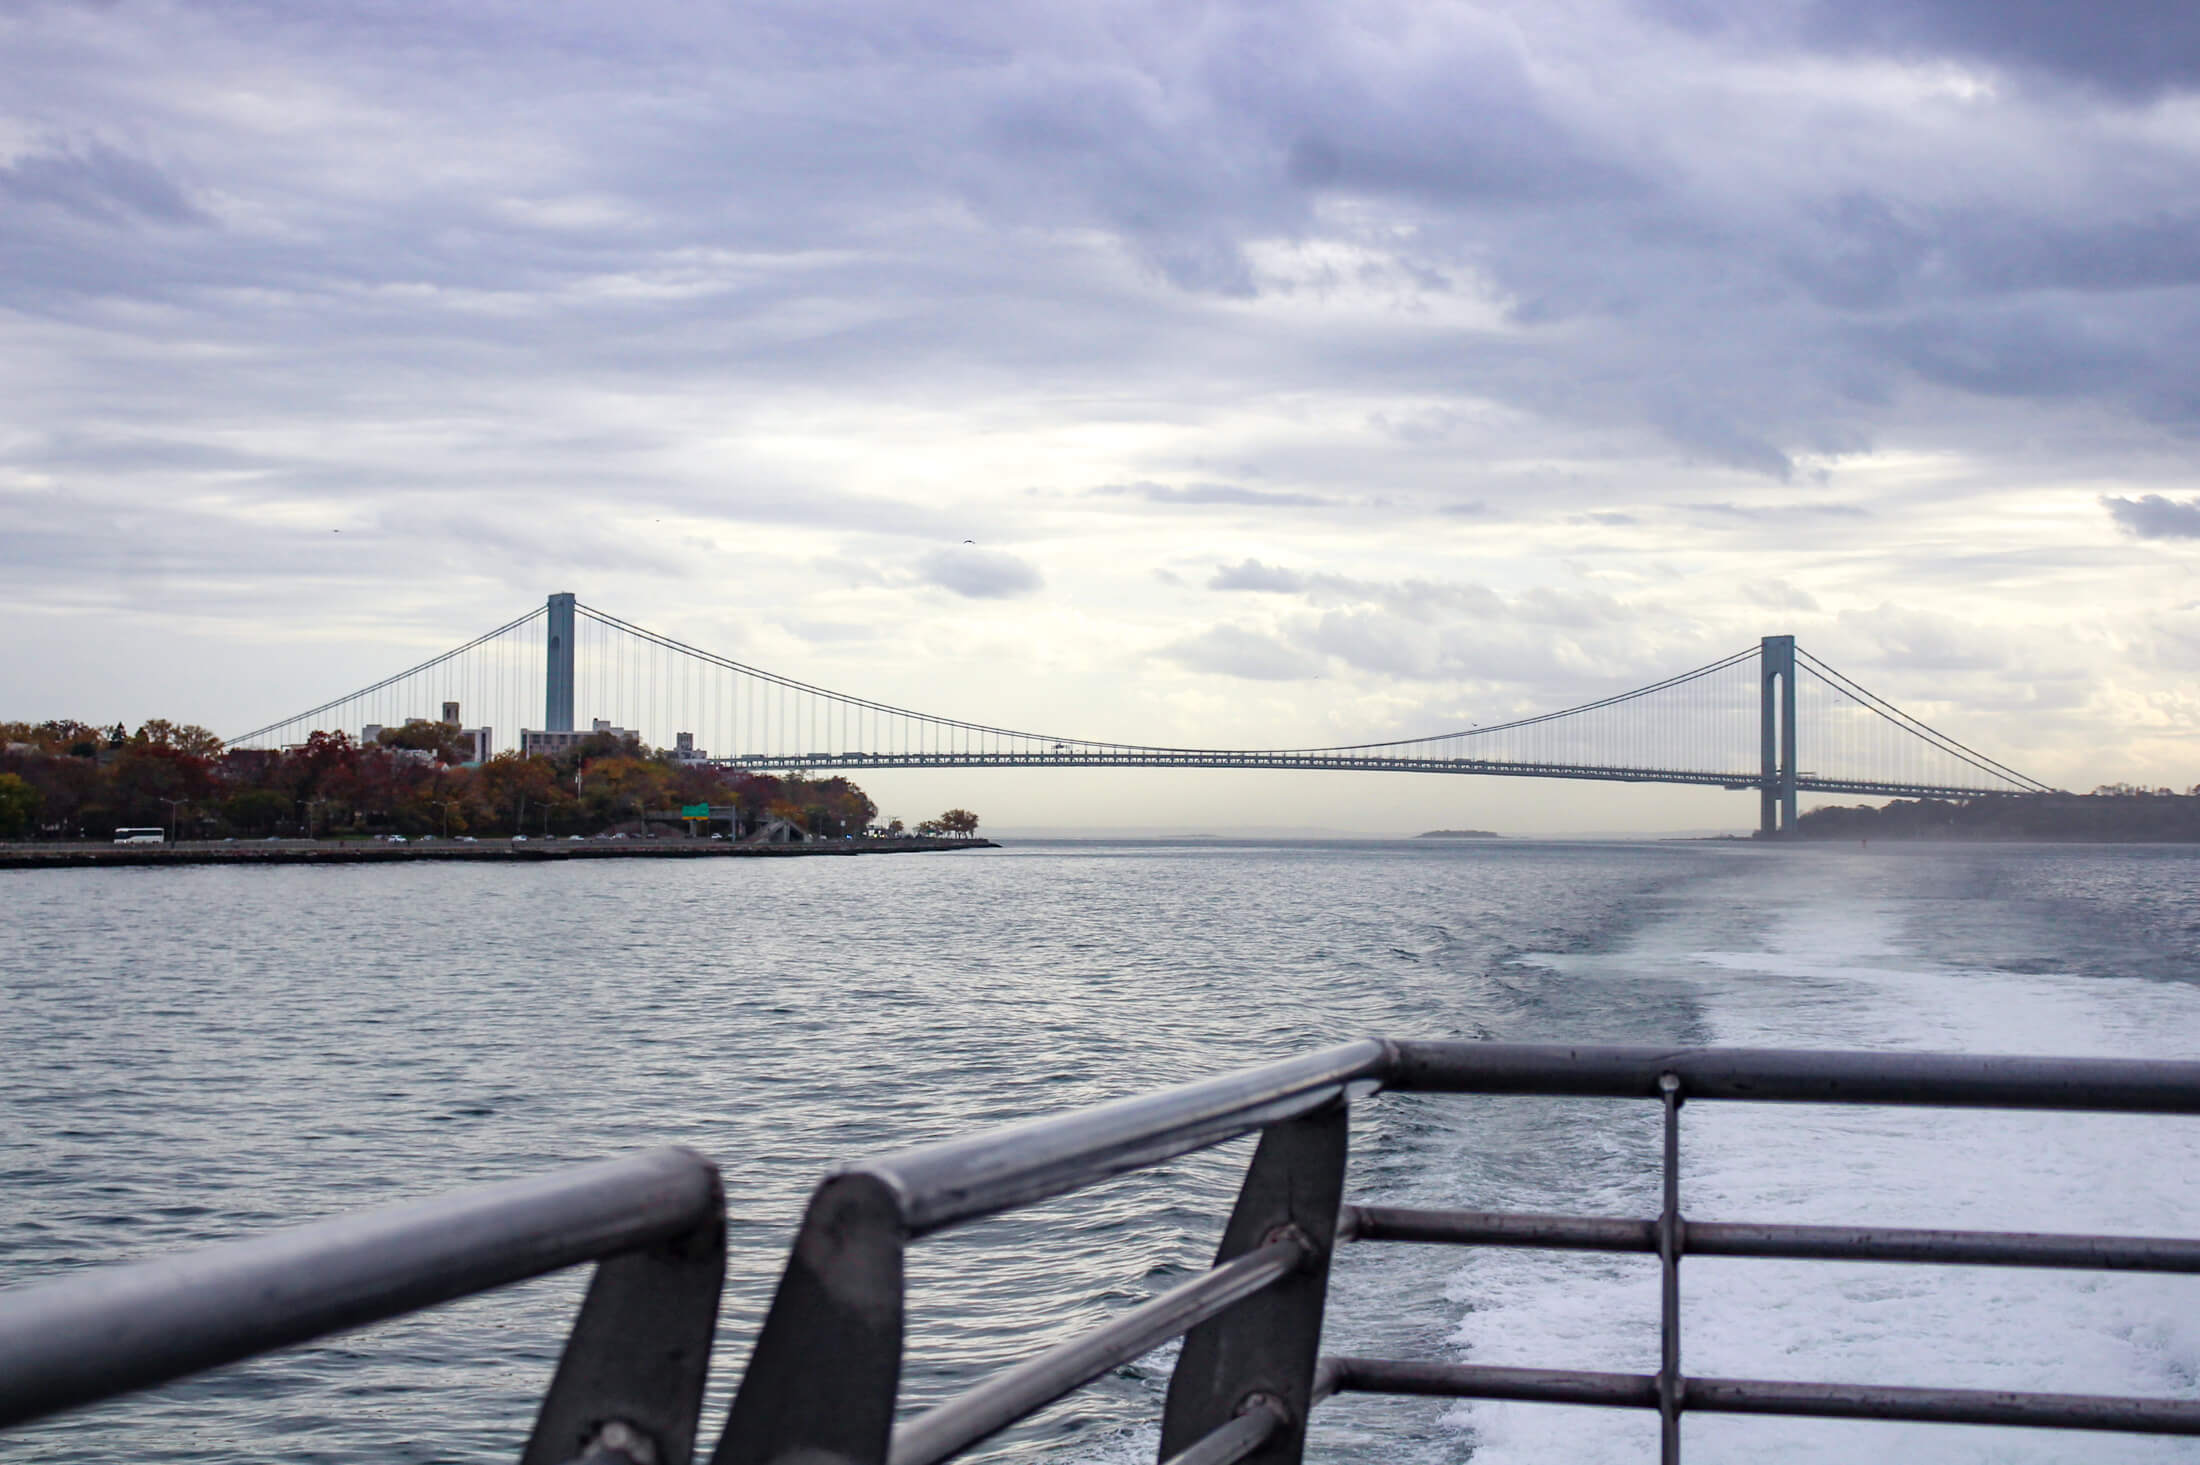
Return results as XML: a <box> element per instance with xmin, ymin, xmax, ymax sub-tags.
<box><xmin>711</xmin><ymin>1172</ymin><xmax>909</xmax><ymax>1465</ymax></box>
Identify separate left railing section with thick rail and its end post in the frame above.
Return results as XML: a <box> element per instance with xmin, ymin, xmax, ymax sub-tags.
<box><xmin>0</xmin><ymin>1148</ymin><xmax>726</xmax><ymax>1465</ymax></box>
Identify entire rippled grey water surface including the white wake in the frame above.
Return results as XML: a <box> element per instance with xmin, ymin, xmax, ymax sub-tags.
<box><xmin>0</xmin><ymin>842</ymin><xmax>2200</xmax><ymax>1465</ymax></box>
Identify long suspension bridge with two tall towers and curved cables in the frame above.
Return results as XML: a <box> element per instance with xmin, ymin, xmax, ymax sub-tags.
<box><xmin>229</xmin><ymin>594</ymin><xmax>2053</xmax><ymax>834</ymax></box>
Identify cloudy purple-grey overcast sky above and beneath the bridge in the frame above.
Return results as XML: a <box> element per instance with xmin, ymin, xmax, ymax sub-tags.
<box><xmin>0</xmin><ymin>0</ymin><xmax>2200</xmax><ymax>831</ymax></box>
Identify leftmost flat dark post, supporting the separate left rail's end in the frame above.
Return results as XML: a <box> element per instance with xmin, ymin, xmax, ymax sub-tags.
<box><xmin>519</xmin><ymin>1168</ymin><xmax>726</xmax><ymax>1465</ymax></box>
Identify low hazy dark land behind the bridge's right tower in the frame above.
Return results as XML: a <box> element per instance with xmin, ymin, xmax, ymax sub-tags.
<box><xmin>1795</xmin><ymin>783</ymin><xmax>2200</xmax><ymax>845</ymax></box>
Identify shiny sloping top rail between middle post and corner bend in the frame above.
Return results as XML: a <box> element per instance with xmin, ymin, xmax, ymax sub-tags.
<box><xmin>851</xmin><ymin>1038</ymin><xmax>1388</xmax><ymax>1236</ymax></box>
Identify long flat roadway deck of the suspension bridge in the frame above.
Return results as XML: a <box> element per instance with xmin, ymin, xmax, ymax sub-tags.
<box><xmin>708</xmin><ymin>748</ymin><xmax>2017</xmax><ymax>798</ymax></box>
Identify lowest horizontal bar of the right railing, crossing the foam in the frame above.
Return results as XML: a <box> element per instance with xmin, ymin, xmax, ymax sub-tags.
<box><xmin>1322</xmin><ymin>1357</ymin><xmax>2200</xmax><ymax>1434</ymax></box>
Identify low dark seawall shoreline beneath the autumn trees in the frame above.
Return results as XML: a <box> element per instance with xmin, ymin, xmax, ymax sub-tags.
<box><xmin>0</xmin><ymin>836</ymin><xmax>999</xmax><ymax>869</ymax></box>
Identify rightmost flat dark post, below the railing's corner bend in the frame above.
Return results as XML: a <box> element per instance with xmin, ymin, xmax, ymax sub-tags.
<box><xmin>1159</xmin><ymin>1100</ymin><xmax>1346</xmax><ymax>1465</ymax></box>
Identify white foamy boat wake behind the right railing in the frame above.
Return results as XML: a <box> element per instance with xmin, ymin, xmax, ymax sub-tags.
<box><xmin>1448</xmin><ymin>869</ymin><xmax>2200</xmax><ymax>1465</ymax></box>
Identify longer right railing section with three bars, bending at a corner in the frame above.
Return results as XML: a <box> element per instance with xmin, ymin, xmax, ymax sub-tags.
<box><xmin>713</xmin><ymin>1040</ymin><xmax>2200</xmax><ymax>1465</ymax></box>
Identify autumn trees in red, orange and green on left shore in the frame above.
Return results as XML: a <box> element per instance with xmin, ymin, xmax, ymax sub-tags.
<box><xmin>0</xmin><ymin>719</ymin><xmax>979</xmax><ymax>838</ymax></box>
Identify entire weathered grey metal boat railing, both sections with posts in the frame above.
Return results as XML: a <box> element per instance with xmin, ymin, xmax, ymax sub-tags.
<box><xmin>0</xmin><ymin>1040</ymin><xmax>2200</xmax><ymax>1465</ymax></box>
